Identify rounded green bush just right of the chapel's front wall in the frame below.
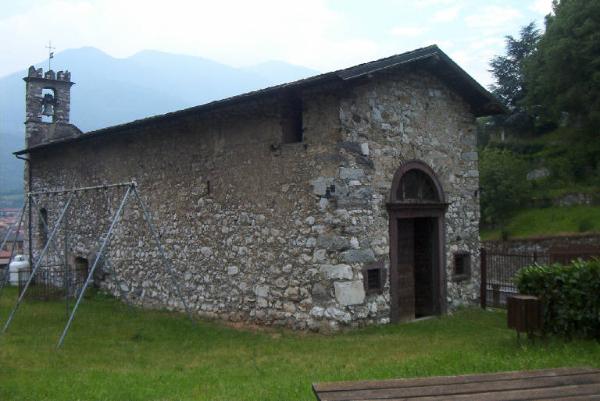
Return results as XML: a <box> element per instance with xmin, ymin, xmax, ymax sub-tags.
<box><xmin>479</xmin><ymin>147</ymin><xmax>530</xmax><ymax>225</ymax></box>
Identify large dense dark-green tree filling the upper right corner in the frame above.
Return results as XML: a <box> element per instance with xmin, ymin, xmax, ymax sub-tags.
<box><xmin>524</xmin><ymin>0</ymin><xmax>600</xmax><ymax>129</ymax></box>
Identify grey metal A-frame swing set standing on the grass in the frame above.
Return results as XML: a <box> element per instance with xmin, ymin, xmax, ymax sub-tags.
<box><xmin>0</xmin><ymin>181</ymin><xmax>194</xmax><ymax>348</ymax></box>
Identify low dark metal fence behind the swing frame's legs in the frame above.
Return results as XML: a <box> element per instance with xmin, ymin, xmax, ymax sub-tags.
<box><xmin>19</xmin><ymin>265</ymin><xmax>87</xmax><ymax>301</ymax></box>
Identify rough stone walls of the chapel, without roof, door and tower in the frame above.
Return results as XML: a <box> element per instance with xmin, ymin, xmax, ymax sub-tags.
<box><xmin>31</xmin><ymin>71</ymin><xmax>479</xmax><ymax>330</ymax></box>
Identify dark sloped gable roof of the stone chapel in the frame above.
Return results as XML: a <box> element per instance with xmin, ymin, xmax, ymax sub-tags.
<box><xmin>14</xmin><ymin>45</ymin><xmax>506</xmax><ymax>155</ymax></box>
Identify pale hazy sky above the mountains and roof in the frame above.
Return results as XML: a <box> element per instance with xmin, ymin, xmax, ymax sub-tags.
<box><xmin>0</xmin><ymin>0</ymin><xmax>552</xmax><ymax>86</ymax></box>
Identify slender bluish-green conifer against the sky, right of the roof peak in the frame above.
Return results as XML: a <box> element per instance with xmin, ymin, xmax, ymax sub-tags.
<box><xmin>490</xmin><ymin>22</ymin><xmax>540</xmax><ymax>112</ymax></box>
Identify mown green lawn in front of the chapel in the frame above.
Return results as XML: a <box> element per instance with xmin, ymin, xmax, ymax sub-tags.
<box><xmin>0</xmin><ymin>289</ymin><xmax>600</xmax><ymax>401</ymax></box>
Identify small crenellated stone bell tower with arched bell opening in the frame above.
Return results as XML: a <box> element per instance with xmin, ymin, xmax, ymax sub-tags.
<box><xmin>23</xmin><ymin>66</ymin><xmax>81</xmax><ymax>148</ymax></box>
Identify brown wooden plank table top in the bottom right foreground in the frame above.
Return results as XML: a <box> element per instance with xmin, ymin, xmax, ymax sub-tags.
<box><xmin>313</xmin><ymin>368</ymin><xmax>600</xmax><ymax>401</ymax></box>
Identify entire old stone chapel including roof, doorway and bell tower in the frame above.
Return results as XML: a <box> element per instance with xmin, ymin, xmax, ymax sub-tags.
<box><xmin>15</xmin><ymin>46</ymin><xmax>503</xmax><ymax>331</ymax></box>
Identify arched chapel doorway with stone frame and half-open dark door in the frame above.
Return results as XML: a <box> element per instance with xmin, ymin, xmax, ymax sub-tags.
<box><xmin>387</xmin><ymin>160</ymin><xmax>448</xmax><ymax>322</ymax></box>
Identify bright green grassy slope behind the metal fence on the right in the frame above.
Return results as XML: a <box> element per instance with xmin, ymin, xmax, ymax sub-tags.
<box><xmin>481</xmin><ymin>206</ymin><xmax>600</xmax><ymax>240</ymax></box>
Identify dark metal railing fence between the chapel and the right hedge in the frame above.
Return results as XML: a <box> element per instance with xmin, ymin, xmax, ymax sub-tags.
<box><xmin>480</xmin><ymin>247</ymin><xmax>600</xmax><ymax>308</ymax></box>
